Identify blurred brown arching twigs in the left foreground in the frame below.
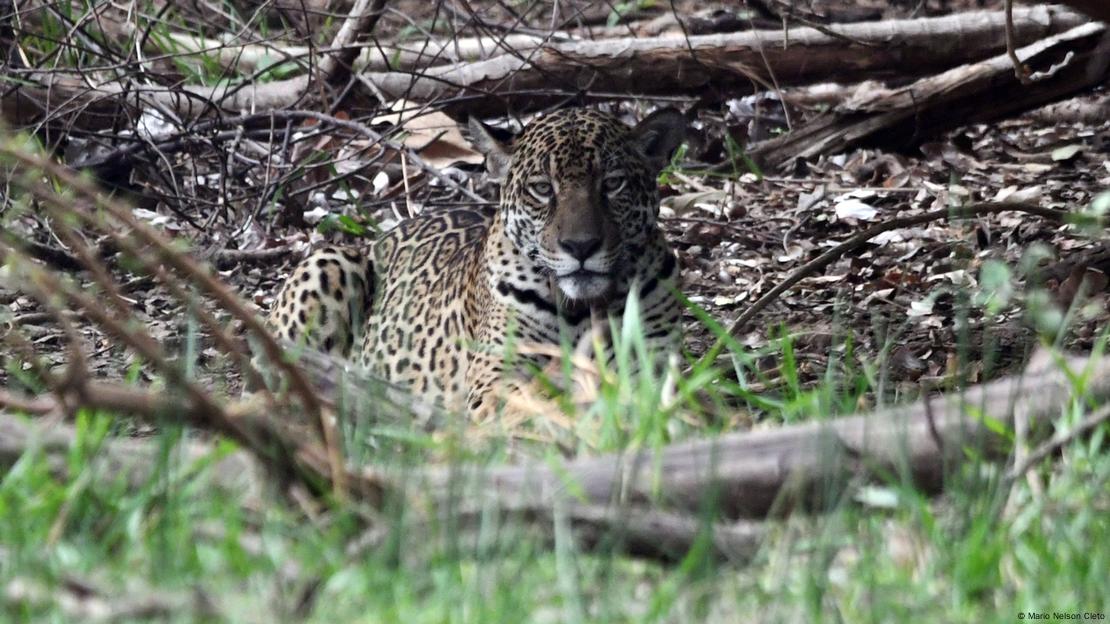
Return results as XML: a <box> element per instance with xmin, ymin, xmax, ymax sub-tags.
<box><xmin>0</xmin><ymin>145</ymin><xmax>364</xmax><ymax>496</ymax></box>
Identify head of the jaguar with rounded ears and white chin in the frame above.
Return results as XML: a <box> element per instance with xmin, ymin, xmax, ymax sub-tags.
<box><xmin>470</xmin><ymin>109</ymin><xmax>686</xmax><ymax>302</ymax></box>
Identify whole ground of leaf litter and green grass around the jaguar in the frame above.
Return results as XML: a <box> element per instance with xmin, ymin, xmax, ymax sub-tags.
<box><xmin>0</xmin><ymin>0</ymin><xmax>1110</xmax><ymax>624</ymax></box>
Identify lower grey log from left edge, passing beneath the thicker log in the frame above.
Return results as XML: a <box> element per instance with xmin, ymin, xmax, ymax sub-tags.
<box><xmin>0</xmin><ymin>404</ymin><xmax>766</xmax><ymax>564</ymax></box>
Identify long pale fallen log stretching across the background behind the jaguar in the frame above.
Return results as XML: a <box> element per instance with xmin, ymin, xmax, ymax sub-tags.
<box><xmin>0</xmin><ymin>7</ymin><xmax>1084</xmax><ymax>130</ymax></box>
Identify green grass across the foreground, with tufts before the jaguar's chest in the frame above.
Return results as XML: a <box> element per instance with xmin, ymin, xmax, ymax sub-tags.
<box><xmin>0</xmin><ymin>283</ymin><xmax>1110</xmax><ymax>623</ymax></box>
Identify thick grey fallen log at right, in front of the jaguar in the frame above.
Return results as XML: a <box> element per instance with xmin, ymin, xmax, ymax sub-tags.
<box><xmin>437</xmin><ymin>359</ymin><xmax>1110</xmax><ymax>517</ymax></box>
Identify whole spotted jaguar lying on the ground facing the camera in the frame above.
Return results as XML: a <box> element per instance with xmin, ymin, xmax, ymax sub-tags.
<box><xmin>269</xmin><ymin>109</ymin><xmax>685</xmax><ymax>419</ymax></box>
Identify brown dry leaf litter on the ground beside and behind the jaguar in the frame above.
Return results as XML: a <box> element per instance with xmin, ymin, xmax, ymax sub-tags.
<box><xmin>0</xmin><ymin>0</ymin><xmax>1110</xmax><ymax>410</ymax></box>
